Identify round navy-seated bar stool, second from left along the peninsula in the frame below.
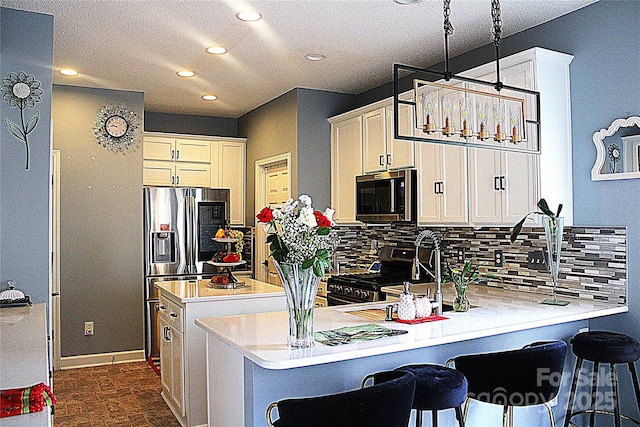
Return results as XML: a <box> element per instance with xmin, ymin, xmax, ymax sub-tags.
<box><xmin>363</xmin><ymin>364</ymin><xmax>467</xmax><ymax>427</ymax></box>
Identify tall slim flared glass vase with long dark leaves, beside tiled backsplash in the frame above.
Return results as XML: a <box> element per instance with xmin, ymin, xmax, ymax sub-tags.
<box><xmin>511</xmin><ymin>199</ymin><xmax>569</xmax><ymax>306</ymax></box>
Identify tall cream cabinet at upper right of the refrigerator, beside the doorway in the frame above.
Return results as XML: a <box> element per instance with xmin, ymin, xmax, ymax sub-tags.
<box><xmin>210</xmin><ymin>140</ymin><xmax>246</xmax><ymax>225</ymax></box>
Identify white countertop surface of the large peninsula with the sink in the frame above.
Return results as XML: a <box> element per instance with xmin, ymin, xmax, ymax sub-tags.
<box><xmin>196</xmin><ymin>286</ymin><xmax>628</xmax><ymax>369</ymax></box>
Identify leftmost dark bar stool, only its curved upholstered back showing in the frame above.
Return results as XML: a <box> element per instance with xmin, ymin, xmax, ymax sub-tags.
<box><xmin>266</xmin><ymin>371</ymin><xmax>416</xmax><ymax>427</ymax></box>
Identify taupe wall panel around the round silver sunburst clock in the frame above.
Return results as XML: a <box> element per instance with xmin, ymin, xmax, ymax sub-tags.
<box><xmin>52</xmin><ymin>85</ymin><xmax>144</xmax><ymax>357</ymax></box>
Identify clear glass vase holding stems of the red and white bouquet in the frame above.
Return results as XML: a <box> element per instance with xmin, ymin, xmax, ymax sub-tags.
<box><xmin>273</xmin><ymin>260</ymin><xmax>320</xmax><ymax>349</ymax></box>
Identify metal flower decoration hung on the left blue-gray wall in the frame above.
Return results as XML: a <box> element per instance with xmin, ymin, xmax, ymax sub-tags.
<box><xmin>0</xmin><ymin>71</ymin><xmax>43</xmax><ymax>170</ymax></box>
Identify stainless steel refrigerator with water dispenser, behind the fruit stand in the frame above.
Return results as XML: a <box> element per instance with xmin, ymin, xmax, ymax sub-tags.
<box><xmin>144</xmin><ymin>187</ymin><xmax>229</xmax><ymax>360</ymax></box>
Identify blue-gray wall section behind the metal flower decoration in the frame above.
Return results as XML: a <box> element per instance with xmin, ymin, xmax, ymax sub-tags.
<box><xmin>0</xmin><ymin>8</ymin><xmax>53</xmax><ymax>302</ymax></box>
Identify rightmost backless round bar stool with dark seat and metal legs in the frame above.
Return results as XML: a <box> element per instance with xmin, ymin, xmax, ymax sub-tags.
<box><xmin>564</xmin><ymin>331</ymin><xmax>640</xmax><ymax>427</ymax></box>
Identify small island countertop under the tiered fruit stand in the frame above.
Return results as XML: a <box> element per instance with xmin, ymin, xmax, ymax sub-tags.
<box><xmin>154</xmin><ymin>278</ymin><xmax>284</xmax><ymax>303</ymax></box>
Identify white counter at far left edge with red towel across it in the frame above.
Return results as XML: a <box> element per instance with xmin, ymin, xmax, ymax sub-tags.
<box><xmin>0</xmin><ymin>304</ymin><xmax>51</xmax><ymax>427</ymax></box>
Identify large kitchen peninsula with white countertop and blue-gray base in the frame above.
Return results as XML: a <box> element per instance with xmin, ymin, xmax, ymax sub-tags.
<box><xmin>196</xmin><ymin>286</ymin><xmax>627</xmax><ymax>426</ymax></box>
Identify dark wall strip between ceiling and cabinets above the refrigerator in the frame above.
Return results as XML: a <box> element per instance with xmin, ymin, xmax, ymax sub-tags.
<box><xmin>144</xmin><ymin>111</ymin><xmax>238</xmax><ymax>137</ymax></box>
